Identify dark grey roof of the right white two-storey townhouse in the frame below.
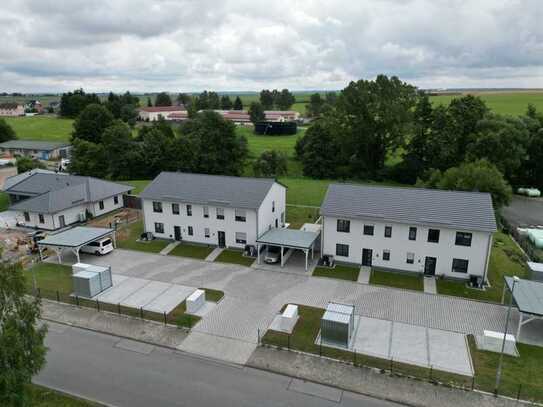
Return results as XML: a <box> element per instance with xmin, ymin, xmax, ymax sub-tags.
<box><xmin>320</xmin><ymin>184</ymin><xmax>496</xmax><ymax>232</ymax></box>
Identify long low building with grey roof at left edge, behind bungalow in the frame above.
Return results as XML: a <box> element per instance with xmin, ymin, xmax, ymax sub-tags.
<box><xmin>0</xmin><ymin>140</ymin><xmax>72</xmax><ymax>160</ymax></box>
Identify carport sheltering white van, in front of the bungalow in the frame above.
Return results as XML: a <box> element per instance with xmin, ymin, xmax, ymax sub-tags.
<box><xmin>38</xmin><ymin>226</ymin><xmax>117</xmax><ymax>263</ymax></box>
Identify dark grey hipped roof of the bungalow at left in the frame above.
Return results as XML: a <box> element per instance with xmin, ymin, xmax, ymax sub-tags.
<box><xmin>4</xmin><ymin>171</ymin><xmax>133</xmax><ymax>213</ymax></box>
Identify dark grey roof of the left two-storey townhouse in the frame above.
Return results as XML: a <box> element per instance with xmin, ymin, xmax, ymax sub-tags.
<box><xmin>140</xmin><ymin>172</ymin><xmax>275</xmax><ymax>209</ymax></box>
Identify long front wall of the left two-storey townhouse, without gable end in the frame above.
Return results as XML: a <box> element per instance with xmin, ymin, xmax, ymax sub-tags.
<box><xmin>143</xmin><ymin>199</ymin><xmax>256</xmax><ymax>248</ymax></box>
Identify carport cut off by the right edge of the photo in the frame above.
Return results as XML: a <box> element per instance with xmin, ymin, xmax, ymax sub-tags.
<box><xmin>502</xmin><ymin>277</ymin><xmax>543</xmax><ymax>340</ymax></box>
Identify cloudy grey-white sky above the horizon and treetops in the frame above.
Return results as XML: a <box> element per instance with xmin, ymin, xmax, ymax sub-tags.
<box><xmin>0</xmin><ymin>0</ymin><xmax>543</xmax><ymax>92</ymax></box>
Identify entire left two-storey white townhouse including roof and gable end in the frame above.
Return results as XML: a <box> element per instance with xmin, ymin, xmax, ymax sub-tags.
<box><xmin>140</xmin><ymin>172</ymin><xmax>286</xmax><ymax>248</ymax></box>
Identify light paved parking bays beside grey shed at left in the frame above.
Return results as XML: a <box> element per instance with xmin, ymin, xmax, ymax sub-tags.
<box><xmin>94</xmin><ymin>274</ymin><xmax>195</xmax><ymax>314</ymax></box>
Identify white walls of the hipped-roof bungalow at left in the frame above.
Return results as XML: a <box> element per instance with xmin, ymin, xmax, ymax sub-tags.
<box><xmin>15</xmin><ymin>194</ymin><xmax>123</xmax><ymax>230</ymax></box>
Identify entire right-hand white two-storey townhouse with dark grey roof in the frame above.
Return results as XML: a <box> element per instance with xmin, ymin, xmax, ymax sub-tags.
<box><xmin>320</xmin><ymin>184</ymin><xmax>496</xmax><ymax>281</ymax></box>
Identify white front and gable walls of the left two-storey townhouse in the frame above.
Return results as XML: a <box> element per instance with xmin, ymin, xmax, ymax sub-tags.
<box><xmin>143</xmin><ymin>183</ymin><xmax>286</xmax><ymax>248</ymax></box>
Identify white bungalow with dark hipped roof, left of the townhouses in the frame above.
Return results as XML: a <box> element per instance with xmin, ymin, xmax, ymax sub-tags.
<box><xmin>3</xmin><ymin>170</ymin><xmax>133</xmax><ymax>230</ymax></box>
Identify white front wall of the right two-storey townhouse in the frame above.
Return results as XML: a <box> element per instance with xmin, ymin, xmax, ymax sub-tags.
<box><xmin>321</xmin><ymin>216</ymin><xmax>492</xmax><ymax>279</ymax></box>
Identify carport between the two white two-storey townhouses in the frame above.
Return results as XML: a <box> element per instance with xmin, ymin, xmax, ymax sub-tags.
<box><xmin>256</xmin><ymin>228</ymin><xmax>320</xmax><ymax>271</ymax></box>
